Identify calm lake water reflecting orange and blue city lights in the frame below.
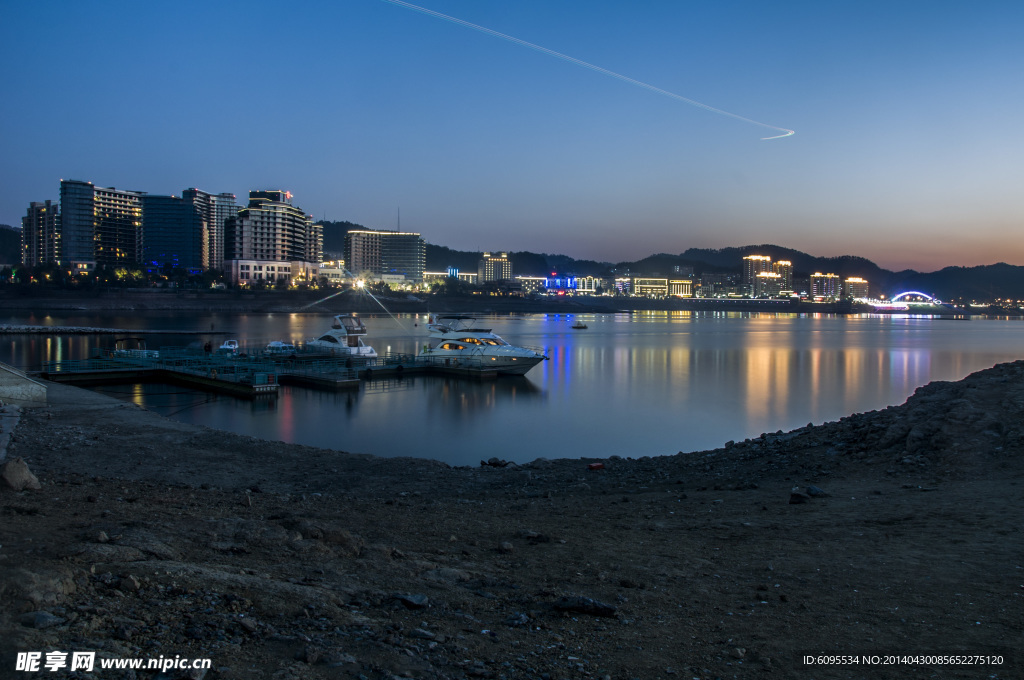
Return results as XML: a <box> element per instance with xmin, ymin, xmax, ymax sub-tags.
<box><xmin>0</xmin><ymin>311</ymin><xmax>1024</xmax><ymax>465</ymax></box>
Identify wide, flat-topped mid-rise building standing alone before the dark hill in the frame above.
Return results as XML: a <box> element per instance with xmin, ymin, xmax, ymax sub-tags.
<box><xmin>345</xmin><ymin>229</ymin><xmax>427</xmax><ymax>284</ymax></box>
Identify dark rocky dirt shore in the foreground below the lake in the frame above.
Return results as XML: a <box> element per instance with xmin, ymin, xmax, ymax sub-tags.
<box><xmin>0</xmin><ymin>363</ymin><xmax>1024</xmax><ymax>680</ymax></box>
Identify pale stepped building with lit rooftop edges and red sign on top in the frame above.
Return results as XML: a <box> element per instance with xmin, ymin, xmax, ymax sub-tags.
<box><xmin>224</xmin><ymin>189</ymin><xmax>323</xmax><ymax>285</ymax></box>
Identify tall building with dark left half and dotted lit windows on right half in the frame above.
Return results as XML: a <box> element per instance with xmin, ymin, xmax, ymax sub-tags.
<box><xmin>60</xmin><ymin>179</ymin><xmax>142</xmax><ymax>266</ymax></box>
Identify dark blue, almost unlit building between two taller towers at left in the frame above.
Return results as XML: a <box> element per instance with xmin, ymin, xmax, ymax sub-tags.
<box><xmin>141</xmin><ymin>194</ymin><xmax>209</xmax><ymax>273</ymax></box>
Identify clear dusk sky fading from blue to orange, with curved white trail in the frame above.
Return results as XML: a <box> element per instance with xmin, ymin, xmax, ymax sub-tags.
<box><xmin>0</xmin><ymin>0</ymin><xmax>1024</xmax><ymax>271</ymax></box>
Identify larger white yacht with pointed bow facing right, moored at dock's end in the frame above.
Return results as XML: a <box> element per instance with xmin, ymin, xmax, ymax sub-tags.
<box><xmin>420</xmin><ymin>314</ymin><xmax>548</xmax><ymax>376</ymax></box>
